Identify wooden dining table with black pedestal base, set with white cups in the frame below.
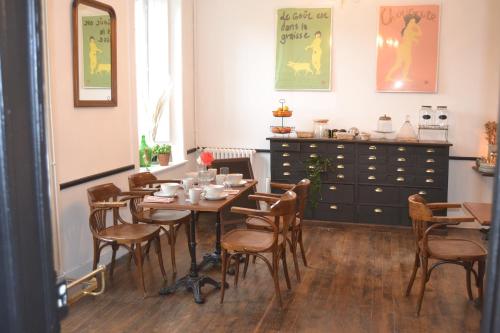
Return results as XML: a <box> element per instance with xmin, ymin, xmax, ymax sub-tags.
<box><xmin>139</xmin><ymin>179</ymin><xmax>257</xmax><ymax>304</ymax></box>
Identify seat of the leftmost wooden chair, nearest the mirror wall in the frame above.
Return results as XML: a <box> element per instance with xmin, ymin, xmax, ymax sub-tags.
<box><xmin>99</xmin><ymin>224</ymin><xmax>160</xmax><ymax>243</ymax></box>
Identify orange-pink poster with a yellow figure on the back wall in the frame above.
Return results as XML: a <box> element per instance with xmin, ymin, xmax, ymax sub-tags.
<box><xmin>377</xmin><ymin>5</ymin><xmax>439</xmax><ymax>93</ymax></box>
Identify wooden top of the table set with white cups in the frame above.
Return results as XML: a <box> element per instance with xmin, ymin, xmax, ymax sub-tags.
<box><xmin>139</xmin><ymin>179</ymin><xmax>257</xmax><ymax>212</ymax></box>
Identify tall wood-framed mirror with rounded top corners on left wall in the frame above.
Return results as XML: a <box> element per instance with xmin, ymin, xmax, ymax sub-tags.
<box><xmin>73</xmin><ymin>0</ymin><xmax>117</xmax><ymax>107</ymax></box>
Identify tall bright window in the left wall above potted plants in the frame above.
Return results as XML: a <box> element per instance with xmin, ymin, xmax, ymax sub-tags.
<box><xmin>135</xmin><ymin>0</ymin><xmax>185</xmax><ymax>161</ymax></box>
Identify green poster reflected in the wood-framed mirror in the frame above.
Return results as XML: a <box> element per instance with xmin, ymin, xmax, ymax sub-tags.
<box><xmin>82</xmin><ymin>15</ymin><xmax>111</xmax><ymax>88</ymax></box>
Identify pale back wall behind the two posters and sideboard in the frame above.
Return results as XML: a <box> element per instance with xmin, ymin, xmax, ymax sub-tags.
<box><xmin>195</xmin><ymin>0</ymin><xmax>500</xmax><ymax>208</ymax></box>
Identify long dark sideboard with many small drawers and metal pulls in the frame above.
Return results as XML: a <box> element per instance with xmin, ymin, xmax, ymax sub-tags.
<box><xmin>268</xmin><ymin>137</ymin><xmax>451</xmax><ymax>226</ymax></box>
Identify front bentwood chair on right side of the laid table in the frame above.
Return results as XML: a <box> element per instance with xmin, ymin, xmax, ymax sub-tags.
<box><xmin>220</xmin><ymin>191</ymin><xmax>297</xmax><ymax>307</ymax></box>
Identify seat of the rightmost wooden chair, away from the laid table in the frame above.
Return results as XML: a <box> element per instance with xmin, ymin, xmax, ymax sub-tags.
<box><xmin>427</xmin><ymin>239</ymin><xmax>488</xmax><ymax>260</ymax></box>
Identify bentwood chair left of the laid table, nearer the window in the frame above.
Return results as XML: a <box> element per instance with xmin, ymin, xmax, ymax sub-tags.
<box><xmin>128</xmin><ymin>172</ymin><xmax>191</xmax><ymax>274</ymax></box>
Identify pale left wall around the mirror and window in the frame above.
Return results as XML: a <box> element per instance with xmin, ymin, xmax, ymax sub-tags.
<box><xmin>46</xmin><ymin>0</ymin><xmax>194</xmax><ymax>277</ymax></box>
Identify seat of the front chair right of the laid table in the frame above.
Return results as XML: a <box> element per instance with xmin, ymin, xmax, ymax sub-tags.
<box><xmin>221</xmin><ymin>229</ymin><xmax>283</xmax><ymax>252</ymax></box>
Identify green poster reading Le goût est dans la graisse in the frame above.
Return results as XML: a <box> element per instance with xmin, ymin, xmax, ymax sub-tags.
<box><xmin>275</xmin><ymin>8</ymin><xmax>332</xmax><ymax>90</ymax></box>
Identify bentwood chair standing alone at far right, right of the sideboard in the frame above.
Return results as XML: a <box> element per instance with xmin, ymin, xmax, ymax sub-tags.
<box><xmin>406</xmin><ymin>194</ymin><xmax>487</xmax><ymax>315</ymax></box>
